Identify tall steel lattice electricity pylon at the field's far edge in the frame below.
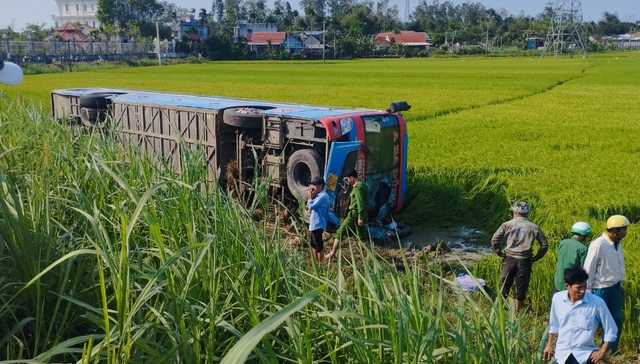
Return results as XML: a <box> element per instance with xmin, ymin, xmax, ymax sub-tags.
<box><xmin>542</xmin><ymin>0</ymin><xmax>587</xmax><ymax>58</ymax></box>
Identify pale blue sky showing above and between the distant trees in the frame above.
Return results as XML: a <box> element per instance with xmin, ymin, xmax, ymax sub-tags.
<box><xmin>0</xmin><ymin>0</ymin><xmax>640</xmax><ymax>31</ymax></box>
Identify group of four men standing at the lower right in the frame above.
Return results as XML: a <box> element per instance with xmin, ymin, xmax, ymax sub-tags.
<box><xmin>491</xmin><ymin>202</ymin><xmax>640</xmax><ymax>364</ymax></box>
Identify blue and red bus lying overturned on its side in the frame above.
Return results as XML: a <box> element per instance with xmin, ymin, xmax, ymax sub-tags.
<box><xmin>51</xmin><ymin>88</ymin><xmax>410</xmax><ymax>225</ymax></box>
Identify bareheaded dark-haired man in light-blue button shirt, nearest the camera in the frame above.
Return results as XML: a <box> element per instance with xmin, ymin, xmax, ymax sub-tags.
<box><xmin>544</xmin><ymin>266</ymin><xmax>618</xmax><ymax>364</ymax></box>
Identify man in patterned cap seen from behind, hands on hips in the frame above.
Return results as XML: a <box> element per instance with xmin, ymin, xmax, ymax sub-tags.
<box><xmin>491</xmin><ymin>202</ymin><xmax>548</xmax><ymax>311</ymax></box>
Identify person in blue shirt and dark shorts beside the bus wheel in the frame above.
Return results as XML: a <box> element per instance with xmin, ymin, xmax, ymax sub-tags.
<box><xmin>307</xmin><ymin>177</ymin><xmax>329</xmax><ymax>263</ymax></box>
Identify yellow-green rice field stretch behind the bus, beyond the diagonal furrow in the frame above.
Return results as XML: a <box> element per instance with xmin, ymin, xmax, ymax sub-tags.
<box><xmin>0</xmin><ymin>58</ymin><xmax>593</xmax><ymax>112</ymax></box>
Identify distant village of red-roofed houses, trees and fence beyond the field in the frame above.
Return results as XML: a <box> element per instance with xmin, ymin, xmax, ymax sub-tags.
<box><xmin>0</xmin><ymin>0</ymin><xmax>640</xmax><ymax>63</ymax></box>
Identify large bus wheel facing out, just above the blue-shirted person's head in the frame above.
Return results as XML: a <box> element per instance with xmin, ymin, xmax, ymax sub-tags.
<box><xmin>287</xmin><ymin>149</ymin><xmax>324</xmax><ymax>199</ymax></box>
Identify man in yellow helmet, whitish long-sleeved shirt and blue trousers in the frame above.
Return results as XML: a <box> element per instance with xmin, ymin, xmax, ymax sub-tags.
<box><xmin>584</xmin><ymin>215</ymin><xmax>629</xmax><ymax>353</ymax></box>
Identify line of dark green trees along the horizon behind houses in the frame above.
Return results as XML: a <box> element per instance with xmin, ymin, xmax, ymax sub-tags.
<box><xmin>2</xmin><ymin>0</ymin><xmax>640</xmax><ymax>59</ymax></box>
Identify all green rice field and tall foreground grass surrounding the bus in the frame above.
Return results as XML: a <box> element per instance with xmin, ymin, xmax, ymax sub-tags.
<box><xmin>0</xmin><ymin>52</ymin><xmax>640</xmax><ymax>363</ymax></box>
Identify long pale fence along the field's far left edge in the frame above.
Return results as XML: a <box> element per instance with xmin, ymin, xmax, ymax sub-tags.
<box><xmin>0</xmin><ymin>34</ymin><xmax>187</xmax><ymax>64</ymax></box>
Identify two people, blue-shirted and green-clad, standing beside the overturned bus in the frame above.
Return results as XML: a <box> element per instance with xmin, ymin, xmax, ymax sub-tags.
<box><xmin>307</xmin><ymin>169</ymin><xmax>368</xmax><ymax>263</ymax></box>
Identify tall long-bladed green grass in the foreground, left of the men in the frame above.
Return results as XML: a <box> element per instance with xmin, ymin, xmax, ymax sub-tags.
<box><xmin>0</xmin><ymin>90</ymin><xmax>544</xmax><ymax>363</ymax></box>
